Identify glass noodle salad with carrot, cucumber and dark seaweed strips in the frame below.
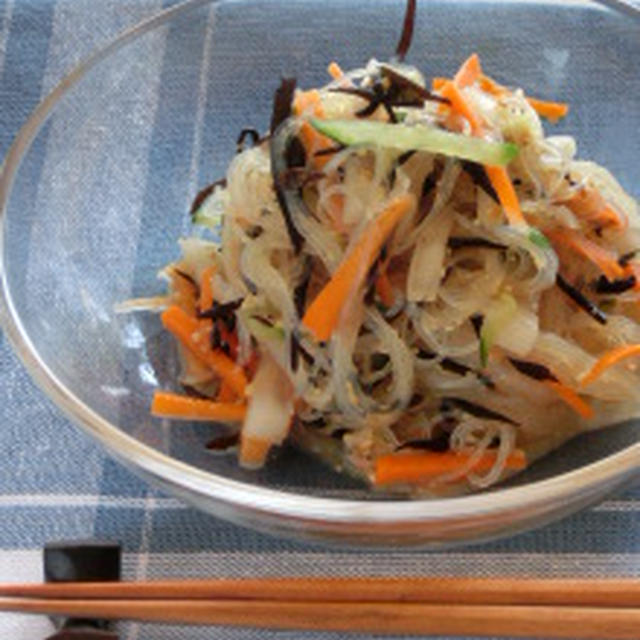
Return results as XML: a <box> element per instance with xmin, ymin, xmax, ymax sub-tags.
<box><xmin>133</xmin><ymin>1</ymin><xmax>640</xmax><ymax>495</ymax></box>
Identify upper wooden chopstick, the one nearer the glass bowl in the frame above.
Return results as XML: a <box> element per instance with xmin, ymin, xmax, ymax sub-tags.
<box><xmin>0</xmin><ymin>578</ymin><xmax>640</xmax><ymax>608</ymax></box>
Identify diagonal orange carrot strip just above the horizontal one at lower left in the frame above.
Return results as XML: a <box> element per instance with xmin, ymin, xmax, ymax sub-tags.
<box><xmin>161</xmin><ymin>306</ymin><xmax>247</xmax><ymax>398</ymax></box>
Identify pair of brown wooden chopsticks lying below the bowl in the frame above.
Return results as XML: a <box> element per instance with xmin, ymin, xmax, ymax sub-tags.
<box><xmin>0</xmin><ymin>578</ymin><xmax>640</xmax><ymax>640</ymax></box>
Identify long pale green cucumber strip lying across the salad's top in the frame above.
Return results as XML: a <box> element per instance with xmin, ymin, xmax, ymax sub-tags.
<box><xmin>310</xmin><ymin>118</ymin><xmax>518</xmax><ymax>166</ymax></box>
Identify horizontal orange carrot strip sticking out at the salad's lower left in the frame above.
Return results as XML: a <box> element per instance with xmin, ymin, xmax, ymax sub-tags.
<box><xmin>151</xmin><ymin>391</ymin><xmax>247</xmax><ymax>422</ymax></box>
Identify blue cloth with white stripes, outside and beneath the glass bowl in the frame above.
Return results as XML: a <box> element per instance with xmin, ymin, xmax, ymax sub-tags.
<box><xmin>0</xmin><ymin>0</ymin><xmax>640</xmax><ymax>640</ymax></box>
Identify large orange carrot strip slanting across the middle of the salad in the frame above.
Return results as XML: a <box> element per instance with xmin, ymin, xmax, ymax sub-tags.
<box><xmin>302</xmin><ymin>195</ymin><xmax>415</xmax><ymax>341</ymax></box>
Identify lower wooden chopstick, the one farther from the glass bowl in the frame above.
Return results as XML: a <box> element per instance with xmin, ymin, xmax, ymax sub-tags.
<box><xmin>0</xmin><ymin>598</ymin><xmax>640</xmax><ymax>640</ymax></box>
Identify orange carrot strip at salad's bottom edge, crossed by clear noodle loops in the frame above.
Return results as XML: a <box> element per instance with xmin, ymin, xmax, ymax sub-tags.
<box><xmin>375</xmin><ymin>449</ymin><xmax>527</xmax><ymax>486</ymax></box>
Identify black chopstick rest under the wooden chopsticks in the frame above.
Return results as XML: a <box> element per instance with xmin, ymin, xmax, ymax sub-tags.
<box><xmin>43</xmin><ymin>540</ymin><xmax>122</xmax><ymax>640</ymax></box>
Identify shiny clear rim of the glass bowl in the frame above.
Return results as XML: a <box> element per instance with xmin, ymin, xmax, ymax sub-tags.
<box><xmin>0</xmin><ymin>0</ymin><xmax>640</xmax><ymax>542</ymax></box>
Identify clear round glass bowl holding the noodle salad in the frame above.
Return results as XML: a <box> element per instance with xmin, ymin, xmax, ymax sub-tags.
<box><xmin>0</xmin><ymin>0</ymin><xmax>640</xmax><ymax>546</ymax></box>
